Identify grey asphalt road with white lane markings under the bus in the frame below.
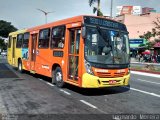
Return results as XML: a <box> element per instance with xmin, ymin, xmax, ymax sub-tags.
<box><xmin>0</xmin><ymin>55</ymin><xmax>160</xmax><ymax>119</ymax></box>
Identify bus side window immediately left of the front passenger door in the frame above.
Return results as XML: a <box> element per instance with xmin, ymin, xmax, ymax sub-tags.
<box><xmin>51</xmin><ymin>26</ymin><xmax>65</xmax><ymax>48</ymax></box>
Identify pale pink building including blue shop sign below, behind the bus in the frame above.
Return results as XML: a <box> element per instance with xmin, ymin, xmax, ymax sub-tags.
<box><xmin>115</xmin><ymin>12</ymin><xmax>160</xmax><ymax>56</ymax></box>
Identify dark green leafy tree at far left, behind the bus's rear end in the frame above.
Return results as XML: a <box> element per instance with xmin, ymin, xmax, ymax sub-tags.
<box><xmin>0</xmin><ymin>20</ymin><xmax>17</xmax><ymax>38</ymax></box>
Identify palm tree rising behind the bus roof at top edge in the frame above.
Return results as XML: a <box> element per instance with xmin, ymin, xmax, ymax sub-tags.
<box><xmin>89</xmin><ymin>0</ymin><xmax>103</xmax><ymax>16</ymax></box>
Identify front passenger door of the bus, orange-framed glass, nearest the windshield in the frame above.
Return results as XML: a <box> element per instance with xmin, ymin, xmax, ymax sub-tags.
<box><xmin>68</xmin><ymin>28</ymin><xmax>81</xmax><ymax>82</ymax></box>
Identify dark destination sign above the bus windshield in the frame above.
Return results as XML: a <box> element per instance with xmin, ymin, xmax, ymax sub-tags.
<box><xmin>84</xmin><ymin>16</ymin><xmax>126</xmax><ymax>31</ymax></box>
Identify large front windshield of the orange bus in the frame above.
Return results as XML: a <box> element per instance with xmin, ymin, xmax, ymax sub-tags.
<box><xmin>85</xmin><ymin>26</ymin><xmax>129</xmax><ymax>64</ymax></box>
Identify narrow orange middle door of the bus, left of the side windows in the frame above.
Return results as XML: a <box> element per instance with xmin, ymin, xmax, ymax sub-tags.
<box><xmin>30</xmin><ymin>34</ymin><xmax>37</xmax><ymax>71</ymax></box>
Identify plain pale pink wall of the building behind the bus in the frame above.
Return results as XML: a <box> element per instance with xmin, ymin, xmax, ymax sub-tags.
<box><xmin>115</xmin><ymin>13</ymin><xmax>160</xmax><ymax>39</ymax></box>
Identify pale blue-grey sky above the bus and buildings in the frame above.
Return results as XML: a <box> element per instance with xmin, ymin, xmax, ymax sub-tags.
<box><xmin>0</xmin><ymin>0</ymin><xmax>160</xmax><ymax>29</ymax></box>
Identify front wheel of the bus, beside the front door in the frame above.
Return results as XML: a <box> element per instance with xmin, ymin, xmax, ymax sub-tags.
<box><xmin>54</xmin><ymin>67</ymin><xmax>65</xmax><ymax>88</ymax></box>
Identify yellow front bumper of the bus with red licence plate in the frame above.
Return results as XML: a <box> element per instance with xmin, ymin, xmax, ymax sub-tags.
<box><xmin>82</xmin><ymin>73</ymin><xmax>130</xmax><ymax>88</ymax></box>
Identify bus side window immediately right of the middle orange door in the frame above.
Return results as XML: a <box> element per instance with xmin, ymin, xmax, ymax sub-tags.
<box><xmin>38</xmin><ymin>28</ymin><xmax>50</xmax><ymax>48</ymax></box>
